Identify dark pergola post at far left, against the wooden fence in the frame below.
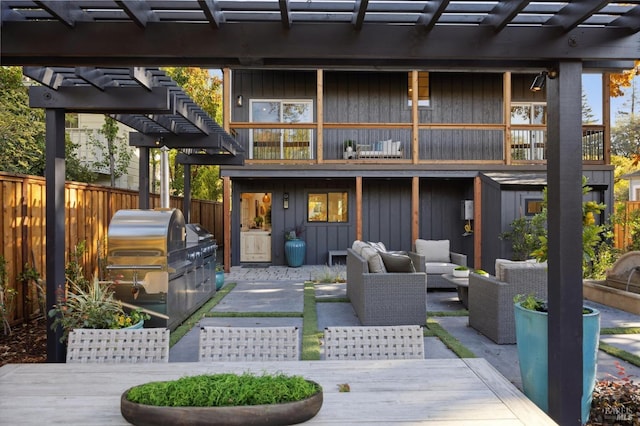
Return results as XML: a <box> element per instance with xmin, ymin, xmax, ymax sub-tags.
<box><xmin>45</xmin><ymin>109</ymin><xmax>66</xmax><ymax>362</ymax></box>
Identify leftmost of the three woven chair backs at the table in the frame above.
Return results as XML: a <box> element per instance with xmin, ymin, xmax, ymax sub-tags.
<box><xmin>67</xmin><ymin>328</ymin><xmax>169</xmax><ymax>363</ymax></box>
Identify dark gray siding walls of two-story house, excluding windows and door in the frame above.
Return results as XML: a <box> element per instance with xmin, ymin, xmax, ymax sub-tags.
<box><xmin>221</xmin><ymin>69</ymin><xmax>613</xmax><ymax>272</ymax></box>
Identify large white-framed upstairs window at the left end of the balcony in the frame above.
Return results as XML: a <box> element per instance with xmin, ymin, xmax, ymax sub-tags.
<box><xmin>249</xmin><ymin>99</ymin><xmax>313</xmax><ymax>160</ymax></box>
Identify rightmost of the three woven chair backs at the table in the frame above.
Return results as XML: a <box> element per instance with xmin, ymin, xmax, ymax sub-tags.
<box><xmin>324</xmin><ymin>325</ymin><xmax>424</xmax><ymax>360</ymax></box>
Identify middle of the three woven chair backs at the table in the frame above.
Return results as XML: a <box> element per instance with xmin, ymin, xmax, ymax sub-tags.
<box><xmin>198</xmin><ymin>327</ymin><xmax>300</xmax><ymax>361</ymax></box>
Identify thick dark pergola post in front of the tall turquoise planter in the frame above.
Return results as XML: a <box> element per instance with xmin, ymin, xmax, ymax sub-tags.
<box><xmin>547</xmin><ymin>62</ymin><xmax>583</xmax><ymax>425</ymax></box>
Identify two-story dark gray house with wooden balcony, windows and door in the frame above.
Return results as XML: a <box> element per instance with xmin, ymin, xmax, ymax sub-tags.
<box><xmin>221</xmin><ymin>68</ymin><xmax>613</xmax><ymax>271</ymax></box>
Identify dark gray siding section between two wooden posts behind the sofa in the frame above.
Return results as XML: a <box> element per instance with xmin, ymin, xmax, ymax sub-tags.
<box><xmin>362</xmin><ymin>179</ymin><xmax>413</xmax><ymax>250</ymax></box>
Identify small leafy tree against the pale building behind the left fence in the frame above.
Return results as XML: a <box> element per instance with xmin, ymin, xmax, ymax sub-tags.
<box><xmin>89</xmin><ymin>115</ymin><xmax>133</xmax><ymax>187</ymax></box>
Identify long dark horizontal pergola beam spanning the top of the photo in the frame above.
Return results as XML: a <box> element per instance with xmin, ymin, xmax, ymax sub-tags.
<box><xmin>0</xmin><ymin>22</ymin><xmax>640</xmax><ymax>67</ymax></box>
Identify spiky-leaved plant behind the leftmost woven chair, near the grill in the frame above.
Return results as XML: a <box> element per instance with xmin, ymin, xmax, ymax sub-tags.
<box><xmin>49</xmin><ymin>277</ymin><xmax>150</xmax><ymax>342</ymax></box>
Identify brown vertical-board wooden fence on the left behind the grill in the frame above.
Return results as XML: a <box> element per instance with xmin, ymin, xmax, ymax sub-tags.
<box><xmin>0</xmin><ymin>172</ymin><xmax>223</xmax><ymax>324</ymax></box>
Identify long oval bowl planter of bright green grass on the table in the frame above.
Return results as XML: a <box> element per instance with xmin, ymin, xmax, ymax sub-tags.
<box><xmin>120</xmin><ymin>373</ymin><xmax>323</xmax><ymax>425</ymax></box>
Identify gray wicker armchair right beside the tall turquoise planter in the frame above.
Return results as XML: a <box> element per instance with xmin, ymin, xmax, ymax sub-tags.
<box><xmin>469</xmin><ymin>263</ymin><xmax>547</xmax><ymax>345</ymax></box>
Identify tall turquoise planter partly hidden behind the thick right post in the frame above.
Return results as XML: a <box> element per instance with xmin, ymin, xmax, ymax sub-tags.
<box><xmin>514</xmin><ymin>303</ymin><xmax>600</xmax><ymax>424</ymax></box>
